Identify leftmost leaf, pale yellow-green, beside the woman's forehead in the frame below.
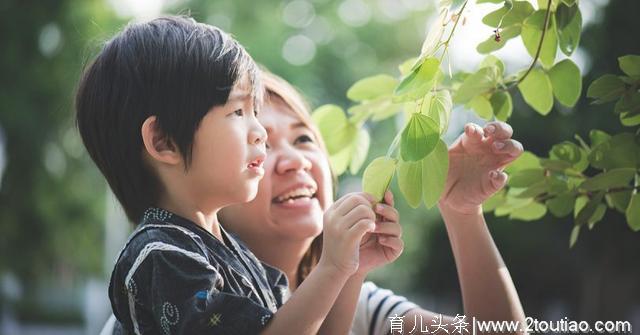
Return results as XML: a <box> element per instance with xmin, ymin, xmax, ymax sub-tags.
<box><xmin>312</xmin><ymin>105</ymin><xmax>357</xmax><ymax>155</ymax></box>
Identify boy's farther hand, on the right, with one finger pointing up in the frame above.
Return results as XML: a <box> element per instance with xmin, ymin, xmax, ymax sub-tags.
<box><xmin>357</xmin><ymin>190</ymin><xmax>404</xmax><ymax>276</ymax></box>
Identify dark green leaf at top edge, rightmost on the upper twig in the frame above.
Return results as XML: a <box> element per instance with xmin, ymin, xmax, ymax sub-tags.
<box><xmin>555</xmin><ymin>3</ymin><xmax>582</xmax><ymax>56</ymax></box>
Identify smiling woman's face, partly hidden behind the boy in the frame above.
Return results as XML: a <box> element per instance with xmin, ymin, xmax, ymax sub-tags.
<box><xmin>221</xmin><ymin>97</ymin><xmax>332</xmax><ymax>244</ymax></box>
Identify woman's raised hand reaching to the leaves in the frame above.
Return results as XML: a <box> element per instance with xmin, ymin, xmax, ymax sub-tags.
<box><xmin>438</xmin><ymin>121</ymin><xmax>523</xmax><ymax>214</ymax></box>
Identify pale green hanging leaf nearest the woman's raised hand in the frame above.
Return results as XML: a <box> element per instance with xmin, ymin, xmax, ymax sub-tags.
<box><xmin>422</xmin><ymin>140</ymin><xmax>449</xmax><ymax>208</ymax></box>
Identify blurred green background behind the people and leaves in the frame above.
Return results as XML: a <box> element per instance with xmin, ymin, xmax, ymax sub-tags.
<box><xmin>0</xmin><ymin>0</ymin><xmax>640</xmax><ymax>335</ymax></box>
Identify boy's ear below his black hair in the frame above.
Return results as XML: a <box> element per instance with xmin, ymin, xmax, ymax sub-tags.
<box><xmin>141</xmin><ymin>115</ymin><xmax>182</xmax><ymax>165</ymax></box>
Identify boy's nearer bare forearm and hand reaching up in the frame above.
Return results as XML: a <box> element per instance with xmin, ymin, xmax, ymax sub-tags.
<box><xmin>262</xmin><ymin>193</ymin><xmax>376</xmax><ymax>334</ymax></box>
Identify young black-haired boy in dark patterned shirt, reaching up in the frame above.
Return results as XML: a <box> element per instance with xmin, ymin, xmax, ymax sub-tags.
<box><xmin>76</xmin><ymin>17</ymin><xmax>375</xmax><ymax>334</ymax></box>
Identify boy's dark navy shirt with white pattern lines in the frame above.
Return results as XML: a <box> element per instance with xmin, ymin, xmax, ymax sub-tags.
<box><xmin>109</xmin><ymin>208</ymin><xmax>289</xmax><ymax>335</ymax></box>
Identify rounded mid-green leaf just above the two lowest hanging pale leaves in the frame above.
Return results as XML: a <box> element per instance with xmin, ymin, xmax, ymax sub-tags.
<box><xmin>400</xmin><ymin>113</ymin><xmax>440</xmax><ymax>162</ymax></box>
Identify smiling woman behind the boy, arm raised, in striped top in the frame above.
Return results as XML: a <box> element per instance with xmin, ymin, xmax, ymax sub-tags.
<box><xmin>221</xmin><ymin>73</ymin><xmax>524</xmax><ymax>334</ymax></box>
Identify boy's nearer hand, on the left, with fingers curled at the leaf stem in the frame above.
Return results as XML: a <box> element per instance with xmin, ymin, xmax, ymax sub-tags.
<box><xmin>318</xmin><ymin>192</ymin><xmax>376</xmax><ymax>277</ymax></box>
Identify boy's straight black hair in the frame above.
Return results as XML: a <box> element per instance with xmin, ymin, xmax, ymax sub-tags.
<box><xmin>76</xmin><ymin>16</ymin><xmax>262</xmax><ymax>223</ymax></box>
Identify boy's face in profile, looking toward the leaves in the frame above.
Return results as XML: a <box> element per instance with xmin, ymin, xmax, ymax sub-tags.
<box><xmin>186</xmin><ymin>82</ymin><xmax>267</xmax><ymax>207</ymax></box>
